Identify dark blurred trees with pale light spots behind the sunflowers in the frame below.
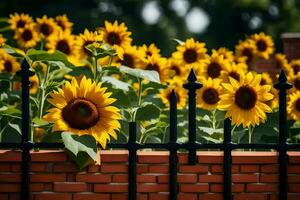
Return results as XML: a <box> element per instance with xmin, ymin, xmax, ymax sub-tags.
<box><xmin>0</xmin><ymin>0</ymin><xmax>300</xmax><ymax>56</ymax></box>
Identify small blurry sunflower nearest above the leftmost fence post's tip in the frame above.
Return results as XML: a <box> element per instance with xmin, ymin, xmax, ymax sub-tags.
<box><xmin>14</xmin><ymin>24</ymin><xmax>40</xmax><ymax>48</ymax></box>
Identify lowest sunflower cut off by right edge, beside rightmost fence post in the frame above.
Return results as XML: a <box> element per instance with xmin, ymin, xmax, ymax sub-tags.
<box><xmin>287</xmin><ymin>91</ymin><xmax>300</xmax><ymax>121</ymax></box>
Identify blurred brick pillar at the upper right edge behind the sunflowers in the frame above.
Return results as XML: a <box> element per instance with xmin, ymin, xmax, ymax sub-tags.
<box><xmin>281</xmin><ymin>33</ymin><xmax>300</xmax><ymax>61</ymax></box>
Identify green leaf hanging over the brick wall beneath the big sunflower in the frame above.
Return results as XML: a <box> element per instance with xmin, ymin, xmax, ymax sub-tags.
<box><xmin>61</xmin><ymin>132</ymin><xmax>99</xmax><ymax>169</ymax></box>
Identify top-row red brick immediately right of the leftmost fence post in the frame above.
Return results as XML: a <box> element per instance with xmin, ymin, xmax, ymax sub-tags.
<box><xmin>31</xmin><ymin>150</ymin><xmax>67</xmax><ymax>162</ymax></box>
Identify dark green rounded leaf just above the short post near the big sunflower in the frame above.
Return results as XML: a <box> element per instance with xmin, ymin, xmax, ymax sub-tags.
<box><xmin>136</xmin><ymin>103</ymin><xmax>160</xmax><ymax>121</ymax></box>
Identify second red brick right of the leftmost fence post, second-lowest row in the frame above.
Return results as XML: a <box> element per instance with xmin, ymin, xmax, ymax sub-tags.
<box><xmin>53</xmin><ymin>182</ymin><xmax>87</xmax><ymax>192</ymax></box>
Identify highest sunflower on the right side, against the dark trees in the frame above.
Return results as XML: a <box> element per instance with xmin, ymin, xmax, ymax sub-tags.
<box><xmin>251</xmin><ymin>33</ymin><xmax>274</xmax><ymax>59</ymax></box>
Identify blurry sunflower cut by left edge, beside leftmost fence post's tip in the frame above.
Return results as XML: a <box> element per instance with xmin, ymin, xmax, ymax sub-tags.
<box><xmin>0</xmin><ymin>50</ymin><xmax>20</xmax><ymax>74</ymax></box>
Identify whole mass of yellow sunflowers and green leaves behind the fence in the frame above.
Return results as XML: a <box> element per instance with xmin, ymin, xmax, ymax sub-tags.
<box><xmin>0</xmin><ymin>13</ymin><xmax>300</xmax><ymax>168</ymax></box>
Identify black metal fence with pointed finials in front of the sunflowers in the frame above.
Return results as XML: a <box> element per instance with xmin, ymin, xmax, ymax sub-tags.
<box><xmin>0</xmin><ymin>60</ymin><xmax>300</xmax><ymax>200</ymax></box>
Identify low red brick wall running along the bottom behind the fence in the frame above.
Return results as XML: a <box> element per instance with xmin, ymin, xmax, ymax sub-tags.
<box><xmin>0</xmin><ymin>150</ymin><xmax>300</xmax><ymax>200</ymax></box>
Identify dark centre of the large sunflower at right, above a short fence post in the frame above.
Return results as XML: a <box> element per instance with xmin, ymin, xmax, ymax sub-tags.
<box><xmin>235</xmin><ymin>86</ymin><xmax>257</xmax><ymax>110</ymax></box>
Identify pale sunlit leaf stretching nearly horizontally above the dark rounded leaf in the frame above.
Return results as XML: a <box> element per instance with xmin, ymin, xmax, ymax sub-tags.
<box><xmin>120</xmin><ymin>66</ymin><xmax>160</xmax><ymax>83</ymax></box>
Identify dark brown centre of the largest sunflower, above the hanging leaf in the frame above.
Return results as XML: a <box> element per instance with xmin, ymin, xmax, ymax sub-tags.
<box><xmin>62</xmin><ymin>99</ymin><xmax>100</xmax><ymax>130</ymax></box>
